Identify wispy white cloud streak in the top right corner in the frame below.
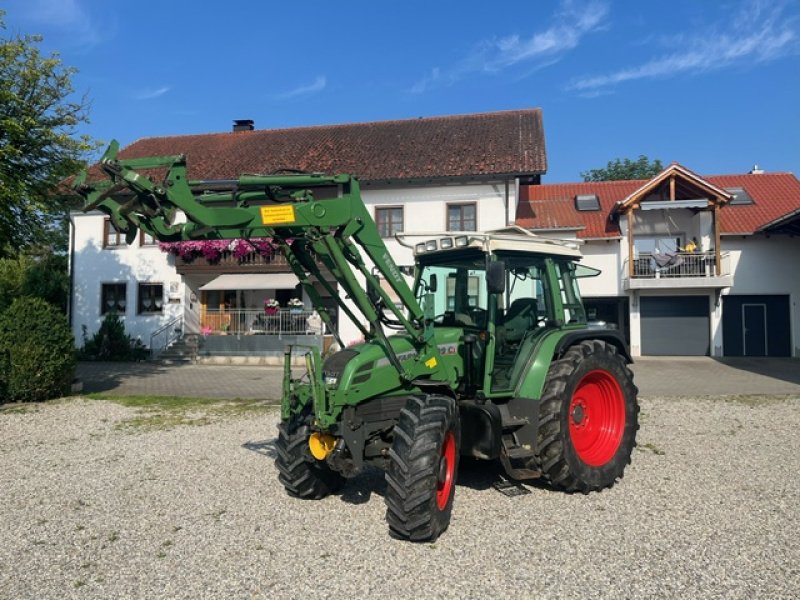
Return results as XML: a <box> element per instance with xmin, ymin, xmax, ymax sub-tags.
<box><xmin>568</xmin><ymin>1</ymin><xmax>800</xmax><ymax>93</ymax></box>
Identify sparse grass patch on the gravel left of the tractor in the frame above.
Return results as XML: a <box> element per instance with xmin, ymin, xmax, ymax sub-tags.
<box><xmin>85</xmin><ymin>393</ymin><xmax>276</xmax><ymax>431</ymax></box>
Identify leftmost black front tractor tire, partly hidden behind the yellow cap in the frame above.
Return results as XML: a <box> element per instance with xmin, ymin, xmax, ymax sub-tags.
<box><xmin>275</xmin><ymin>417</ymin><xmax>344</xmax><ymax>500</ymax></box>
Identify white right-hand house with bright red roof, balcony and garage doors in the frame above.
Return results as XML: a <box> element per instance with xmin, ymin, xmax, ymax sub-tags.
<box><xmin>516</xmin><ymin>164</ymin><xmax>800</xmax><ymax>356</ymax></box>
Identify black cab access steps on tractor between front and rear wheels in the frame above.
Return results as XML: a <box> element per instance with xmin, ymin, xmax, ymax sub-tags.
<box><xmin>498</xmin><ymin>398</ymin><xmax>541</xmax><ymax>480</ymax></box>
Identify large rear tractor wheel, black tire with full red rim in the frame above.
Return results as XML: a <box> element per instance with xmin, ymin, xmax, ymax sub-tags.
<box><xmin>537</xmin><ymin>340</ymin><xmax>639</xmax><ymax>493</ymax></box>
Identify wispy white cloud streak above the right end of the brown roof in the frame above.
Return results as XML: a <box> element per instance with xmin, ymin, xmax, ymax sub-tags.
<box><xmin>409</xmin><ymin>0</ymin><xmax>608</xmax><ymax>94</ymax></box>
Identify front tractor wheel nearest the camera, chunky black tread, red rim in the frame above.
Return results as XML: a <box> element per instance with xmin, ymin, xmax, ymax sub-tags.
<box><xmin>385</xmin><ymin>395</ymin><xmax>461</xmax><ymax>542</ymax></box>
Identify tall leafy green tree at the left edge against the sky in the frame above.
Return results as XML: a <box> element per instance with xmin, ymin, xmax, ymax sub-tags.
<box><xmin>0</xmin><ymin>11</ymin><xmax>97</xmax><ymax>257</ymax></box>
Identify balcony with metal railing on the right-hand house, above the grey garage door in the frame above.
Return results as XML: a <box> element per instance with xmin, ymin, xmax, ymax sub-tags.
<box><xmin>623</xmin><ymin>252</ymin><xmax>733</xmax><ymax>290</ymax></box>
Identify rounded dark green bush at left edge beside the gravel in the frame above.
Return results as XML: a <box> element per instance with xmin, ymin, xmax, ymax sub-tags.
<box><xmin>0</xmin><ymin>298</ymin><xmax>75</xmax><ymax>402</ymax></box>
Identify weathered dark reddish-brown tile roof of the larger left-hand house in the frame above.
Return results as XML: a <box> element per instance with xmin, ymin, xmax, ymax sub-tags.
<box><xmin>112</xmin><ymin>108</ymin><xmax>547</xmax><ymax>181</ymax></box>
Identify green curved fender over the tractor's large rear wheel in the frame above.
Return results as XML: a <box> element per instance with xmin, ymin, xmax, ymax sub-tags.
<box><xmin>514</xmin><ymin>328</ymin><xmax>633</xmax><ymax>400</ymax></box>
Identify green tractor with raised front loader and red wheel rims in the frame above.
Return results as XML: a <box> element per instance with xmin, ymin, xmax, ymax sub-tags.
<box><xmin>75</xmin><ymin>143</ymin><xmax>639</xmax><ymax>541</ymax></box>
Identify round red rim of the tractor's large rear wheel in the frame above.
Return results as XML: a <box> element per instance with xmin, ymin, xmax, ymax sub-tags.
<box><xmin>569</xmin><ymin>370</ymin><xmax>625</xmax><ymax>467</ymax></box>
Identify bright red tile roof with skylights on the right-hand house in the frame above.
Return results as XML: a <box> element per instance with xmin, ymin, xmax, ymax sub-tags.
<box><xmin>516</xmin><ymin>173</ymin><xmax>800</xmax><ymax>238</ymax></box>
